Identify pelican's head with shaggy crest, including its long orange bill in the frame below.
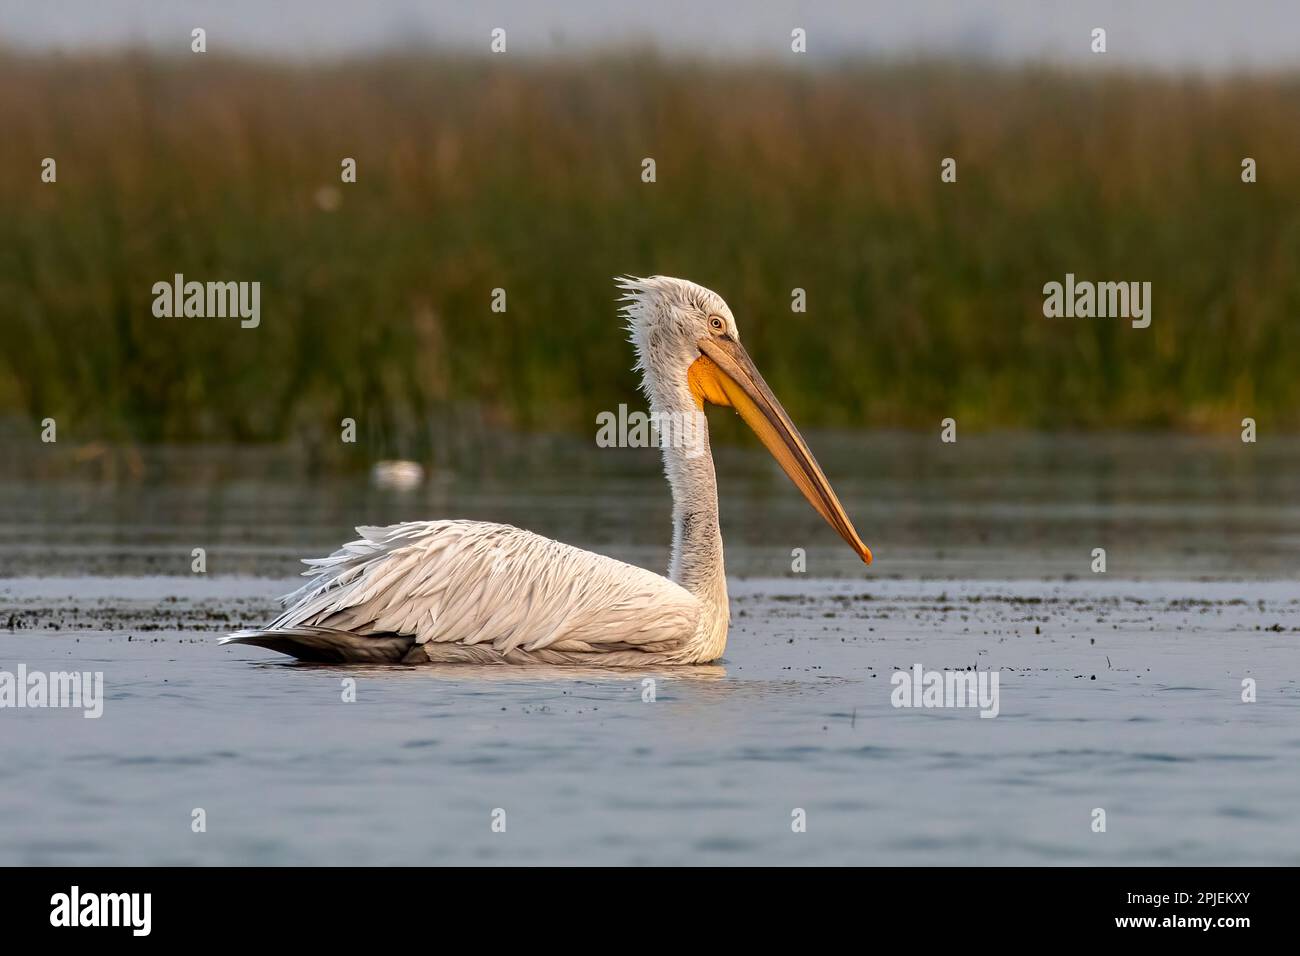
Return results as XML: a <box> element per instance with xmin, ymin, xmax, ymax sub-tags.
<box><xmin>618</xmin><ymin>276</ymin><xmax>871</xmax><ymax>564</ymax></box>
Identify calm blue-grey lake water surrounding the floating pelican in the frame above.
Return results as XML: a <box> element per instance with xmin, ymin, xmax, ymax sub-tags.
<box><xmin>0</xmin><ymin>436</ymin><xmax>1300</xmax><ymax>865</ymax></box>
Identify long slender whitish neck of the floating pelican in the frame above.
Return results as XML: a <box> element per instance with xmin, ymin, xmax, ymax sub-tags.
<box><xmin>650</xmin><ymin>384</ymin><xmax>731</xmax><ymax>654</ymax></box>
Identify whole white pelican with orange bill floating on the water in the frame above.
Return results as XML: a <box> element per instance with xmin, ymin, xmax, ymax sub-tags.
<box><xmin>222</xmin><ymin>276</ymin><xmax>871</xmax><ymax>667</ymax></box>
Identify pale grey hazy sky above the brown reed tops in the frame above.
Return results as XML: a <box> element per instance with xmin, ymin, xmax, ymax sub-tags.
<box><xmin>0</xmin><ymin>0</ymin><xmax>1300</xmax><ymax>72</ymax></box>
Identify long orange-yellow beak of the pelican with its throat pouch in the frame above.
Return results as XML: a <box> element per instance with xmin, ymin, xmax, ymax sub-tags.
<box><xmin>688</xmin><ymin>336</ymin><xmax>871</xmax><ymax>564</ymax></box>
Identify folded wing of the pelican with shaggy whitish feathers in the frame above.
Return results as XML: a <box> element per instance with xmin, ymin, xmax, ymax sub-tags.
<box><xmin>269</xmin><ymin>522</ymin><xmax>699</xmax><ymax>654</ymax></box>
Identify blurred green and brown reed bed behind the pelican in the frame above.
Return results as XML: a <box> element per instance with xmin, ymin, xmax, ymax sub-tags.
<box><xmin>0</xmin><ymin>51</ymin><xmax>1300</xmax><ymax>463</ymax></box>
